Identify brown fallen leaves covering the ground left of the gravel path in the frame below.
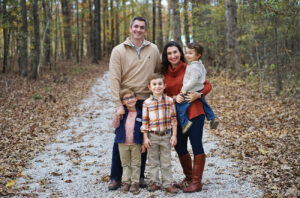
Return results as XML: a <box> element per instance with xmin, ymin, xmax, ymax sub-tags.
<box><xmin>0</xmin><ymin>59</ymin><xmax>107</xmax><ymax>197</ymax></box>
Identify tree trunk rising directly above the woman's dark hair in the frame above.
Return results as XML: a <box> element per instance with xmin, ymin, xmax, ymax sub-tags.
<box><xmin>172</xmin><ymin>0</ymin><xmax>182</xmax><ymax>46</ymax></box>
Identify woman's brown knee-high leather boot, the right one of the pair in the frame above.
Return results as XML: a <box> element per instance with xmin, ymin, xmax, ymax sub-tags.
<box><xmin>183</xmin><ymin>154</ymin><xmax>206</xmax><ymax>193</ymax></box>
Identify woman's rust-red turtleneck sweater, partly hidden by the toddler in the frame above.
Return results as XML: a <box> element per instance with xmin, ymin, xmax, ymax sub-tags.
<box><xmin>165</xmin><ymin>61</ymin><xmax>211</xmax><ymax>120</ymax></box>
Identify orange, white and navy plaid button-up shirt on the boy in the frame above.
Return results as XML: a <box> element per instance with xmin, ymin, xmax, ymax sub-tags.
<box><xmin>141</xmin><ymin>95</ymin><xmax>177</xmax><ymax>133</ymax></box>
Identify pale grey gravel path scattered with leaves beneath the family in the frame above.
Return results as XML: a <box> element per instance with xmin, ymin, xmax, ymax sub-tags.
<box><xmin>15</xmin><ymin>73</ymin><xmax>263</xmax><ymax>198</ymax></box>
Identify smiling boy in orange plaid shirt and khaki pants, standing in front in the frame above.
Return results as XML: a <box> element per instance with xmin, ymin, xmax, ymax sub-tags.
<box><xmin>141</xmin><ymin>74</ymin><xmax>178</xmax><ymax>193</ymax></box>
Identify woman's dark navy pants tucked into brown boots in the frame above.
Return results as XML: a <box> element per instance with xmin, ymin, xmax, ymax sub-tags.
<box><xmin>175</xmin><ymin>115</ymin><xmax>205</xmax><ymax>158</ymax></box>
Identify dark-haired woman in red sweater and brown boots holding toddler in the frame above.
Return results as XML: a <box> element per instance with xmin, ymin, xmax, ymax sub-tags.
<box><xmin>162</xmin><ymin>41</ymin><xmax>211</xmax><ymax>192</ymax></box>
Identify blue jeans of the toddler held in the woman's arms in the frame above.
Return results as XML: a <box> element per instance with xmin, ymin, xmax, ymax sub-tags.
<box><xmin>175</xmin><ymin>97</ymin><xmax>216</xmax><ymax>127</ymax></box>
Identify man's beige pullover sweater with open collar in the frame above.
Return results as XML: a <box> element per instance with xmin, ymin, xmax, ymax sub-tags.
<box><xmin>109</xmin><ymin>38</ymin><xmax>161</xmax><ymax>106</ymax></box>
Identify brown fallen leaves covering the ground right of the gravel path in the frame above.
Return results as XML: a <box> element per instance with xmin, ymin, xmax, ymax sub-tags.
<box><xmin>207</xmin><ymin>76</ymin><xmax>300</xmax><ymax>197</ymax></box>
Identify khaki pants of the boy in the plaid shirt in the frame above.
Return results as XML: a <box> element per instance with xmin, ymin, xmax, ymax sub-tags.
<box><xmin>148</xmin><ymin>133</ymin><xmax>173</xmax><ymax>188</ymax></box>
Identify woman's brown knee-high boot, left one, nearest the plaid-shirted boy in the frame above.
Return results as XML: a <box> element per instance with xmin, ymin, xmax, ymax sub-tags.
<box><xmin>174</xmin><ymin>153</ymin><xmax>193</xmax><ymax>188</ymax></box>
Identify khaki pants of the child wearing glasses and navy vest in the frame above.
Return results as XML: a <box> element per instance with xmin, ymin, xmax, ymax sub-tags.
<box><xmin>119</xmin><ymin>144</ymin><xmax>141</xmax><ymax>184</ymax></box>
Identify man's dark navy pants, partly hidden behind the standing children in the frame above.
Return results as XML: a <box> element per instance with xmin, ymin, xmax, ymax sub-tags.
<box><xmin>110</xmin><ymin>100</ymin><xmax>147</xmax><ymax>181</ymax></box>
